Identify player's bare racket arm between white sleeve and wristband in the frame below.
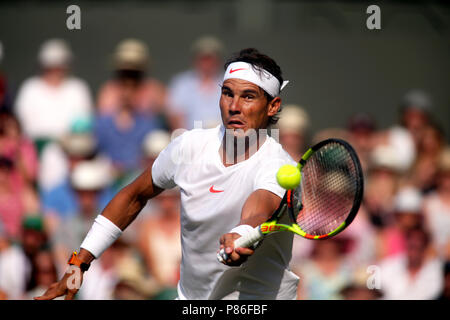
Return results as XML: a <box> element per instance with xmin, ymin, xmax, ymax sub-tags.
<box><xmin>240</xmin><ymin>189</ymin><xmax>281</xmax><ymax>227</ymax></box>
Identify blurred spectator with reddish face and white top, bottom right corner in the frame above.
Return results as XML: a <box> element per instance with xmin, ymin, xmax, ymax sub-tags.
<box><xmin>380</xmin><ymin>227</ymin><xmax>444</xmax><ymax>300</ymax></box>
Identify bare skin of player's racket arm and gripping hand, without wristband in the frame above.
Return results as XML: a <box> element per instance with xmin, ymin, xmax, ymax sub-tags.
<box><xmin>220</xmin><ymin>189</ymin><xmax>281</xmax><ymax>265</ymax></box>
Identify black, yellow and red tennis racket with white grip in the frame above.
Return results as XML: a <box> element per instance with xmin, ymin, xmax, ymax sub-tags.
<box><xmin>217</xmin><ymin>139</ymin><xmax>364</xmax><ymax>262</ymax></box>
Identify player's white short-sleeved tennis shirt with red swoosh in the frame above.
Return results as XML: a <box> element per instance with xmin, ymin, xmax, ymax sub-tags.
<box><xmin>152</xmin><ymin>125</ymin><xmax>298</xmax><ymax>299</ymax></box>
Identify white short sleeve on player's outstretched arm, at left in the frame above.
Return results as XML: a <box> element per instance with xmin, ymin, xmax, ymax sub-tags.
<box><xmin>152</xmin><ymin>134</ymin><xmax>184</xmax><ymax>189</ymax></box>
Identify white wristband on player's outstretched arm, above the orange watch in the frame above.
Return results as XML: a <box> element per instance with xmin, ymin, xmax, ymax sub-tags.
<box><xmin>80</xmin><ymin>214</ymin><xmax>122</xmax><ymax>259</ymax></box>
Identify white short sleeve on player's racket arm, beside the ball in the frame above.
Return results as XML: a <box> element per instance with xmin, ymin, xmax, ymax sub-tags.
<box><xmin>253</xmin><ymin>152</ymin><xmax>295</xmax><ymax>198</ymax></box>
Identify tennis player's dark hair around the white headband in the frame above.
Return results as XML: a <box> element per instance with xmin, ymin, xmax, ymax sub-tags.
<box><xmin>224</xmin><ymin>48</ymin><xmax>283</xmax><ymax>124</ymax></box>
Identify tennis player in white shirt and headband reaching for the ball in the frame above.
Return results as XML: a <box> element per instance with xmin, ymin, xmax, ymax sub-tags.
<box><xmin>36</xmin><ymin>49</ymin><xmax>298</xmax><ymax>300</ymax></box>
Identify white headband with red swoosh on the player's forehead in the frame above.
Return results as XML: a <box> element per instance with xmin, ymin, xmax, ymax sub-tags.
<box><xmin>223</xmin><ymin>61</ymin><xmax>289</xmax><ymax>97</ymax></box>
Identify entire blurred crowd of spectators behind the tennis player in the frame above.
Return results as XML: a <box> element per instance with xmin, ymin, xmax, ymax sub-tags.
<box><xmin>0</xmin><ymin>36</ymin><xmax>450</xmax><ymax>299</ymax></box>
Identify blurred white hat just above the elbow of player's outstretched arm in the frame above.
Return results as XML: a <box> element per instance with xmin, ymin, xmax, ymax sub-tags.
<box><xmin>71</xmin><ymin>158</ymin><xmax>112</xmax><ymax>190</ymax></box>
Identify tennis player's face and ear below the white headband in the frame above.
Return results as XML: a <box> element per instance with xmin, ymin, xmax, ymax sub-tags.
<box><xmin>219</xmin><ymin>79</ymin><xmax>281</xmax><ymax>132</ymax></box>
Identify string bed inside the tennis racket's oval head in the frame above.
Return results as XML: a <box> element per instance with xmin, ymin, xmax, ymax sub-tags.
<box><xmin>297</xmin><ymin>143</ymin><xmax>357</xmax><ymax>236</ymax></box>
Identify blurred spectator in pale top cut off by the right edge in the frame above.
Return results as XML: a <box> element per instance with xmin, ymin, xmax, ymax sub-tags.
<box><xmin>424</xmin><ymin>147</ymin><xmax>450</xmax><ymax>259</ymax></box>
